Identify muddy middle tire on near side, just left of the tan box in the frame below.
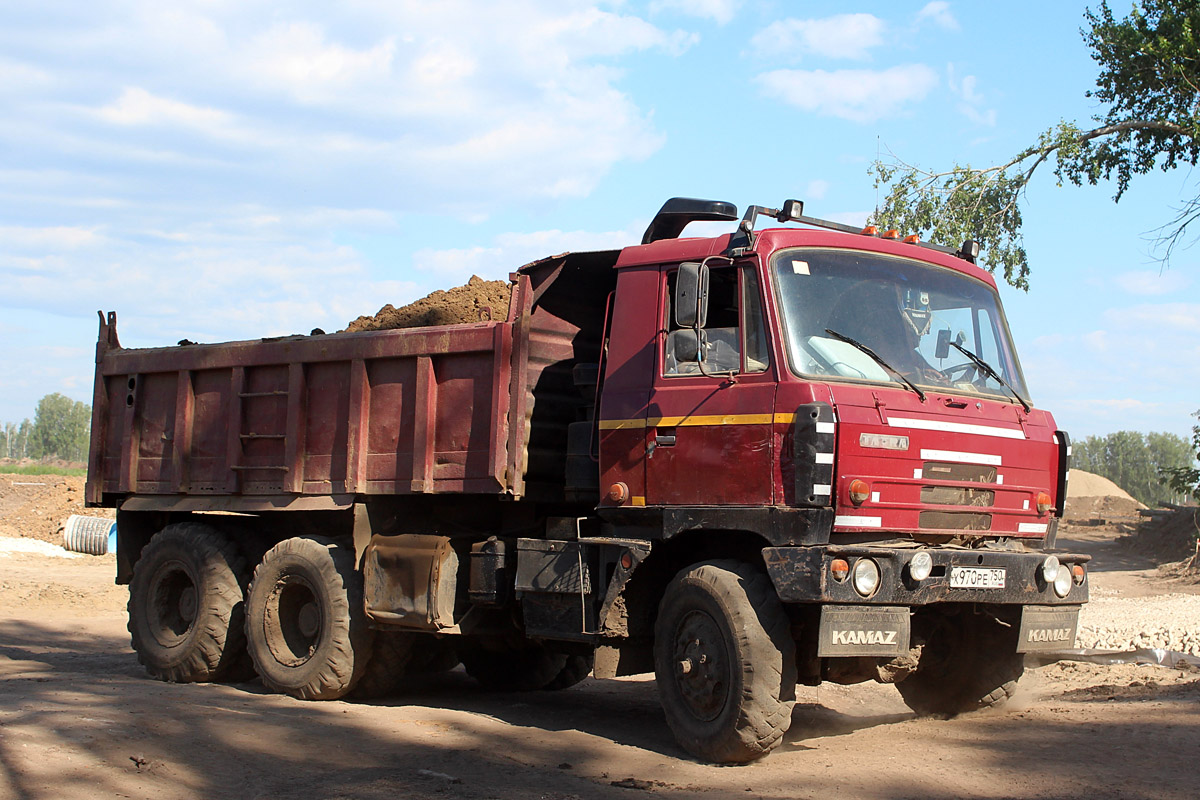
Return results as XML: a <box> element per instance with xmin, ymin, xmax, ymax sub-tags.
<box><xmin>246</xmin><ymin>536</ymin><xmax>374</xmax><ymax>700</ymax></box>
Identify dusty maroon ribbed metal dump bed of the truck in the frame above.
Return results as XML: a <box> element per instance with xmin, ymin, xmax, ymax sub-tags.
<box><xmin>86</xmin><ymin>254</ymin><xmax>613</xmax><ymax>510</ymax></box>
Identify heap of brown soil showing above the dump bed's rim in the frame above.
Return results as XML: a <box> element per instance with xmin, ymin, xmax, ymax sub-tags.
<box><xmin>341</xmin><ymin>275</ymin><xmax>512</xmax><ymax>333</ymax></box>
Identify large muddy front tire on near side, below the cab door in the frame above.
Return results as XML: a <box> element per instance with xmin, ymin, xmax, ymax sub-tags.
<box><xmin>654</xmin><ymin>561</ymin><xmax>796</xmax><ymax>764</ymax></box>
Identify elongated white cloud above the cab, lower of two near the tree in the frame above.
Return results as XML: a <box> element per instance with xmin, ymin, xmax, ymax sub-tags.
<box><xmin>757</xmin><ymin>64</ymin><xmax>937</xmax><ymax>122</ymax></box>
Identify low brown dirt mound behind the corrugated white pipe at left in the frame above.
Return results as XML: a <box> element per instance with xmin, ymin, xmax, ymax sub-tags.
<box><xmin>0</xmin><ymin>474</ymin><xmax>116</xmax><ymax>545</ymax></box>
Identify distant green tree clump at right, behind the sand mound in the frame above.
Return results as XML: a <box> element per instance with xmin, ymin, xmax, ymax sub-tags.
<box><xmin>1070</xmin><ymin>431</ymin><xmax>1192</xmax><ymax>505</ymax></box>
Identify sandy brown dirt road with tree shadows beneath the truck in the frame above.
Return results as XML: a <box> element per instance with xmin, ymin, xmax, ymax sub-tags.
<box><xmin>0</xmin><ymin>522</ymin><xmax>1200</xmax><ymax>800</ymax></box>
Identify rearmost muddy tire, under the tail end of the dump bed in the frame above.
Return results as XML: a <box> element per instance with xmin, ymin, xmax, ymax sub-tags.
<box><xmin>128</xmin><ymin>523</ymin><xmax>248</xmax><ymax>684</ymax></box>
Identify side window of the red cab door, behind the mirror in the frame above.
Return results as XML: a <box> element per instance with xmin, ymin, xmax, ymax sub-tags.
<box><xmin>662</xmin><ymin>266</ymin><xmax>769</xmax><ymax>375</ymax></box>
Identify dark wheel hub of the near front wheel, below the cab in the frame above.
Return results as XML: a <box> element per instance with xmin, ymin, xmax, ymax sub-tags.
<box><xmin>673</xmin><ymin>610</ymin><xmax>731</xmax><ymax>721</ymax></box>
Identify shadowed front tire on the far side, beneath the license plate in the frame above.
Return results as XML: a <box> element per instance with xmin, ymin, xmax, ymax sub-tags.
<box><xmin>896</xmin><ymin>612</ymin><xmax>1025</xmax><ymax>716</ymax></box>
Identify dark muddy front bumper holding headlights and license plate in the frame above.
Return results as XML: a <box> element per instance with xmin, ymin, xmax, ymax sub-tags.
<box><xmin>762</xmin><ymin>545</ymin><xmax>1091</xmax><ymax>606</ymax></box>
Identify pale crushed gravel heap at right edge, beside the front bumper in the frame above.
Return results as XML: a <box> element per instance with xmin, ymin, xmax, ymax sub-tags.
<box><xmin>1076</xmin><ymin>593</ymin><xmax>1200</xmax><ymax>656</ymax></box>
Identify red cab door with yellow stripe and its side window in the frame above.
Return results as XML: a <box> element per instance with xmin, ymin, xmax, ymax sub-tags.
<box><xmin>646</xmin><ymin>265</ymin><xmax>776</xmax><ymax>506</ymax></box>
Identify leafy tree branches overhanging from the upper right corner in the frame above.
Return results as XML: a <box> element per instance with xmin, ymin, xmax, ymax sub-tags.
<box><xmin>871</xmin><ymin>0</ymin><xmax>1200</xmax><ymax>289</ymax></box>
